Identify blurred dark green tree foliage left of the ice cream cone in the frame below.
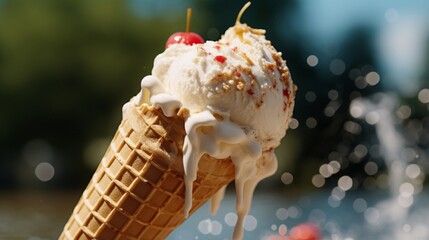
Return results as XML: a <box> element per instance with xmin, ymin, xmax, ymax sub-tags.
<box><xmin>0</xmin><ymin>0</ymin><xmax>189</xmax><ymax>187</ymax></box>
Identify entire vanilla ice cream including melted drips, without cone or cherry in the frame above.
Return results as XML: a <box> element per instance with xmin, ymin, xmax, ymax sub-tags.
<box><xmin>124</xmin><ymin>17</ymin><xmax>296</xmax><ymax>239</ymax></box>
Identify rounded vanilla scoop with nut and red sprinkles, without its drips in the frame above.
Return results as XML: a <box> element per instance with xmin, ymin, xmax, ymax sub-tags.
<box><xmin>152</xmin><ymin>24</ymin><xmax>295</xmax><ymax>150</ymax></box>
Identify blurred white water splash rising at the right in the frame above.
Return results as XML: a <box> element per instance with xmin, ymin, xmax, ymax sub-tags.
<box><xmin>350</xmin><ymin>93</ymin><xmax>422</xmax><ymax>239</ymax></box>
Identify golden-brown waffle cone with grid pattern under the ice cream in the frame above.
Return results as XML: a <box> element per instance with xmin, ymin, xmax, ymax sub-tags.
<box><xmin>60</xmin><ymin>104</ymin><xmax>235</xmax><ymax>240</ymax></box>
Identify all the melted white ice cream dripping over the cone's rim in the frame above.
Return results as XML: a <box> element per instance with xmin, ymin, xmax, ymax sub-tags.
<box><xmin>123</xmin><ymin>76</ymin><xmax>277</xmax><ymax>239</ymax></box>
